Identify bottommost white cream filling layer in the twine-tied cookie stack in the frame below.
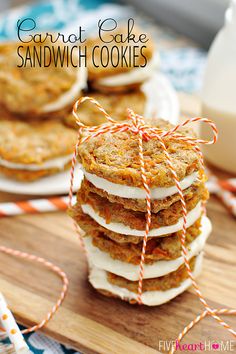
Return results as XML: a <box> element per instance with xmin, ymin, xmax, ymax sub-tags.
<box><xmin>89</xmin><ymin>253</ymin><xmax>203</xmax><ymax>306</ymax></box>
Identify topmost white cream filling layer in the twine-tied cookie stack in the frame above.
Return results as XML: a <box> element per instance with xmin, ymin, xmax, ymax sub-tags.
<box><xmin>83</xmin><ymin>168</ymin><xmax>198</xmax><ymax>199</ymax></box>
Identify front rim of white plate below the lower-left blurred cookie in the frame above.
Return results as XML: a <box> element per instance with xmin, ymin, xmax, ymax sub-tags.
<box><xmin>0</xmin><ymin>166</ymin><xmax>83</xmax><ymax>195</ymax></box>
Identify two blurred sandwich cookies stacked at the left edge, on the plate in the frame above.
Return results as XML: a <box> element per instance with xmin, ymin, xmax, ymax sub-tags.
<box><xmin>0</xmin><ymin>40</ymin><xmax>87</xmax><ymax>182</ymax></box>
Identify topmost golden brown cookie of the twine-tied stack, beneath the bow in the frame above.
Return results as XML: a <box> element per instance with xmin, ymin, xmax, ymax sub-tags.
<box><xmin>78</xmin><ymin>119</ymin><xmax>201</xmax><ymax>188</ymax></box>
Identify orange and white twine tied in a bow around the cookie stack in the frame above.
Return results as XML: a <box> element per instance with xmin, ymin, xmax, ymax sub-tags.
<box><xmin>69</xmin><ymin>97</ymin><xmax>236</xmax><ymax>354</ymax></box>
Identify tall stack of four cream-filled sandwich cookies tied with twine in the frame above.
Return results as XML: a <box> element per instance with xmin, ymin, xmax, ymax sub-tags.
<box><xmin>70</xmin><ymin>120</ymin><xmax>211</xmax><ymax>306</ymax></box>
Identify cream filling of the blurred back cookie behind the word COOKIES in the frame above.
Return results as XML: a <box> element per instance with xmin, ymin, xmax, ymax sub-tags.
<box><xmin>97</xmin><ymin>53</ymin><xmax>160</xmax><ymax>87</ymax></box>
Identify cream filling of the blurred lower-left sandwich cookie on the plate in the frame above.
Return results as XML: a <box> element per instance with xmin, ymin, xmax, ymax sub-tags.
<box><xmin>0</xmin><ymin>155</ymin><xmax>72</xmax><ymax>171</ymax></box>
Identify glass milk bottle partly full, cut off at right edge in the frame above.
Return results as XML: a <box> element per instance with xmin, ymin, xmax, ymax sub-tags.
<box><xmin>201</xmin><ymin>0</ymin><xmax>236</xmax><ymax>174</ymax></box>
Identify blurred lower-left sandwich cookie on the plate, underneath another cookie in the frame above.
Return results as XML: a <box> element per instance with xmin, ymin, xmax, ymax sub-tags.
<box><xmin>0</xmin><ymin>120</ymin><xmax>77</xmax><ymax>182</ymax></box>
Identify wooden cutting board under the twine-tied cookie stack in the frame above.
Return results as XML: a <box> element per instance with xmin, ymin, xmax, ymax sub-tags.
<box><xmin>0</xmin><ymin>95</ymin><xmax>236</xmax><ymax>354</ymax></box>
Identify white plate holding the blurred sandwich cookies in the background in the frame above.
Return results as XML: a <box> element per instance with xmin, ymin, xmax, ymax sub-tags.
<box><xmin>0</xmin><ymin>73</ymin><xmax>179</xmax><ymax>195</ymax></box>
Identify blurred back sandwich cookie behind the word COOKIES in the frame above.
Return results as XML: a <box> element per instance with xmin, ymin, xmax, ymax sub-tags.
<box><xmin>87</xmin><ymin>27</ymin><xmax>159</xmax><ymax>93</ymax></box>
